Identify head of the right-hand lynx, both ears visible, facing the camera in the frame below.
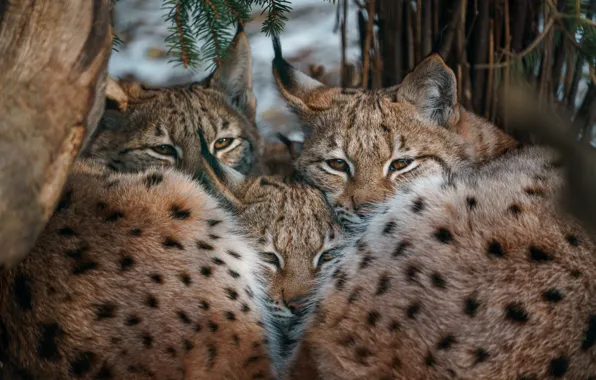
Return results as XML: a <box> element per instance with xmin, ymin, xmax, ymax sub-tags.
<box><xmin>273</xmin><ymin>38</ymin><xmax>512</xmax><ymax>226</ymax></box>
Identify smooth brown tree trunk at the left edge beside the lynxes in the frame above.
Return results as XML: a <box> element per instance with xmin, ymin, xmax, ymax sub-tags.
<box><xmin>0</xmin><ymin>0</ymin><xmax>112</xmax><ymax>267</ymax></box>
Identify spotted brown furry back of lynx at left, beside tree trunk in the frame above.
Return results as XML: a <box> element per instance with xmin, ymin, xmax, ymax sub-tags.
<box><xmin>0</xmin><ymin>163</ymin><xmax>273</xmax><ymax>380</ymax></box>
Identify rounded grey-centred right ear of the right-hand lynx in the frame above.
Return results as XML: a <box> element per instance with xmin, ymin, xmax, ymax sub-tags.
<box><xmin>397</xmin><ymin>54</ymin><xmax>459</xmax><ymax>127</ymax></box>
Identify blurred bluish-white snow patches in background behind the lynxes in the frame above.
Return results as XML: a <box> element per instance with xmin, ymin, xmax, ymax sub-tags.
<box><xmin>109</xmin><ymin>0</ymin><xmax>360</xmax><ymax>139</ymax></box>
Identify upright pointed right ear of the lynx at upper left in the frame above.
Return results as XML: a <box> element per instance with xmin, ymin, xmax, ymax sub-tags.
<box><xmin>206</xmin><ymin>24</ymin><xmax>257</xmax><ymax>123</ymax></box>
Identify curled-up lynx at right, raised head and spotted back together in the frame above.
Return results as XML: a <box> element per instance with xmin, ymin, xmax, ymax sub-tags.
<box><xmin>274</xmin><ymin>37</ymin><xmax>596</xmax><ymax>380</ymax></box>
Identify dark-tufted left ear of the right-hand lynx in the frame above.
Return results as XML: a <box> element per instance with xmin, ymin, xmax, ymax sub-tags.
<box><xmin>273</xmin><ymin>36</ymin><xmax>337</xmax><ymax>120</ymax></box>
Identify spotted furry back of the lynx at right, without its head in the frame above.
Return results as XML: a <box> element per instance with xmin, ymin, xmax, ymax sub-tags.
<box><xmin>299</xmin><ymin>148</ymin><xmax>596</xmax><ymax>380</ymax></box>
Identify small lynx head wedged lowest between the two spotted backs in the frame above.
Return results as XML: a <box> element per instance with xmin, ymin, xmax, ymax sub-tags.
<box><xmin>198</xmin><ymin>132</ymin><xmax>344</xmax><ymax>323</ymax></box>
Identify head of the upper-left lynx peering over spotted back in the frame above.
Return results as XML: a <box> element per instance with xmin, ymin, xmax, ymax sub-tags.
<box><xmin>84</xmin><ymin>29</ymin><xmax>262</xmax><ymax>173</ymax></box>
